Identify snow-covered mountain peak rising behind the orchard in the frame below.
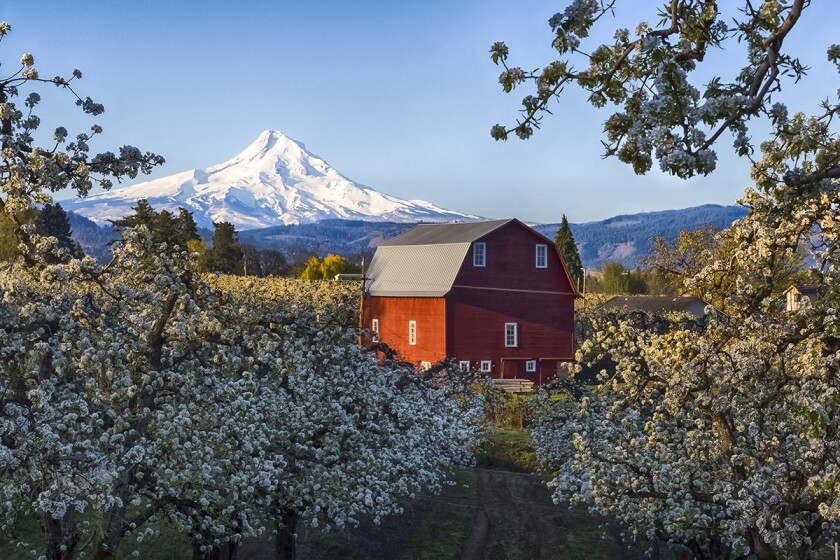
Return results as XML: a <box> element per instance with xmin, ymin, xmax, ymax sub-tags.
<box><xmin>62</xmin><ymin>130</ymin><xmax>478</xmax><ymax>230</ymax></box>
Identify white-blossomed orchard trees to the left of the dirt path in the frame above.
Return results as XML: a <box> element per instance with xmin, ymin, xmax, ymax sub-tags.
<box><xmin>0</xmin><ymin>28</ymin><xmax>481</xmax><ymax>558</ymax></box>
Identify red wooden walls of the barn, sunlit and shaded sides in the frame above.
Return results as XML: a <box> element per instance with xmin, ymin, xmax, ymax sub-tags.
<box><xmin>364</xmin><ymin>220</ymin><xmax>577</xmax><ymax>383</ymax></box>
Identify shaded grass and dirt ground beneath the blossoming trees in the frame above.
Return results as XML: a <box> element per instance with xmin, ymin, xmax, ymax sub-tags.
<box><xmin>0</xmin><ymin>428</ymin><xmax>626</xmax><ymax>560</ymax></box>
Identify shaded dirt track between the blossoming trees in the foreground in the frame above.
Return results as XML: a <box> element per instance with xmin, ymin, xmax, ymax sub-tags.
<box><xmin>239</xmin><ymin>469</ymin><xmax>665</xmax><ymax>560</ymax></box>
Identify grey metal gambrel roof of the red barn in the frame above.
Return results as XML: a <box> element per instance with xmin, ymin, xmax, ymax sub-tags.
<box><xmin>365</xmin><ymin>220</ymin><xmax>515</xmax><ymax>297</ymax></box>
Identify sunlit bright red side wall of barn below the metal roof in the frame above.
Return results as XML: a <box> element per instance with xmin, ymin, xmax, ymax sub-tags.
<box><xmin>364</xmin><ymin>297</ymin><xmax>446</xmax><ymax>363</ymax></box>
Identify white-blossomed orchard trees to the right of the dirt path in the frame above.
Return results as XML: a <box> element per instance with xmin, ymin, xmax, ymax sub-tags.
<box><xmin>534</xmin><ymin>83</ymin><xmax>840</xmax><ymax>558</ymax></box>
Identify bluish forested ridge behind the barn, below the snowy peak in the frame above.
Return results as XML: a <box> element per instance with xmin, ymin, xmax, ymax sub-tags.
<box><xmin>68</xmin><ymin>204</ymin><xmax>746</xmax><ymax>268</ymax></box>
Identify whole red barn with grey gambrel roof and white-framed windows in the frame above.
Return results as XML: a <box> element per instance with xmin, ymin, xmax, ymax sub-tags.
<box><xmin>363</xmin><ymin>220</ymin><xmax>578</xmax><ymax>384</ymax></box>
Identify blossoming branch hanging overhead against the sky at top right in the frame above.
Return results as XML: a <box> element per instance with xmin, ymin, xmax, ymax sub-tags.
<box><xmin>490</xmin><ymin>0</ymin><xmax>840</xmax><ymax>184</ymax></box>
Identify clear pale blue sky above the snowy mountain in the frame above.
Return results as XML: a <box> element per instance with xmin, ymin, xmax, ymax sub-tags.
<box><xmin>6</xmin><ymin>0</ymin><xmax>840</xmax><ymax>222</ymax></box>
